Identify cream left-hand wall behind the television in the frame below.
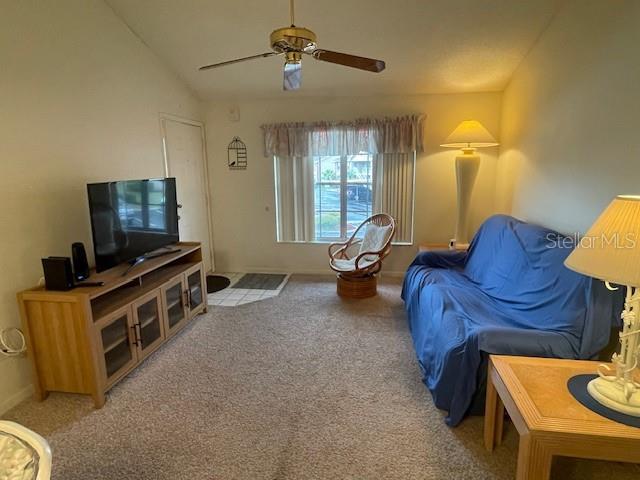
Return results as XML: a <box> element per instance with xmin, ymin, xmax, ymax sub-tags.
<box><xmin>0</xmin><ymin>0</ymin><xmax>200</xmax><ymax>413</ymax></box>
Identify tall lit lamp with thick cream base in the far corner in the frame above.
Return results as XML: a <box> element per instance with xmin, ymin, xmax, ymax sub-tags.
<box><xmin>440</xmin><ymin>120</ymin><xmax>499</xmax><ymax>247</ymax></box>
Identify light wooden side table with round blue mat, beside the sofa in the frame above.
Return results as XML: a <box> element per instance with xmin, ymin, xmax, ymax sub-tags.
<box><xmin>484</xmin><ymin>355</ymin><xmax>640</xmax><ymax>480</ymax></box>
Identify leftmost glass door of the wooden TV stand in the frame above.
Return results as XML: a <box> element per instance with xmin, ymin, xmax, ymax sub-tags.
<box><xmin>98</xmin><ymin>308</ymin><xmax>137</xmax><ymax>383</ymax></box>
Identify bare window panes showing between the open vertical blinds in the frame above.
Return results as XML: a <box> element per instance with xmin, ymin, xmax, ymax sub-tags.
<box><xmin>313</xmin><ymin>154</ymin><xmax>373</xmax><ymax>240</ymax></box>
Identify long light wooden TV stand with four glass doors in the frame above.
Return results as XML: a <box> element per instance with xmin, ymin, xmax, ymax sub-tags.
<box><xmin>18</xmin><ymin>242</ymin><xmax>207</xmax><ymax>408</ymax></box>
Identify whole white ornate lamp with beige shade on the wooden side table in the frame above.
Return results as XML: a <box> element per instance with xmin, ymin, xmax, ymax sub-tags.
<box><xmin>564</xmin><ymin>195</ymin><xmax>640</xmax><ymax>417</ymax></box>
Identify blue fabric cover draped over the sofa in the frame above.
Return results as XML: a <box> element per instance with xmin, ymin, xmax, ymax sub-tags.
<box><xmin>402</xmin><ymin>215</ymin><xmax>622</xmax><ymax>426</ymax></box>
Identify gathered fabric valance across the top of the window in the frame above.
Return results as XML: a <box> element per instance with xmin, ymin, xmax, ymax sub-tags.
<box><xmin>262</xmin><ymin>115</ymin><xmax>424</xmax><ymax>158</ymax></box>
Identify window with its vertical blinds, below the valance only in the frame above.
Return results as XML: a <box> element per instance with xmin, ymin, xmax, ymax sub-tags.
<box><xmin>274</xmin><ymin>153</ymin><xmax>415</xmax><ymax>244</ymax></box>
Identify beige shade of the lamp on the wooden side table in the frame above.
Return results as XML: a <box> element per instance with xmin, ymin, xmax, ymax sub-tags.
<box><xmin>564</xmin><ymin>195</ymin><xmax>640</xmax><ymax>287</ymax></box>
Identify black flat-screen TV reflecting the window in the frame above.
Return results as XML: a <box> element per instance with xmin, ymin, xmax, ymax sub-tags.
<box><xmin>87</xmin><ymin>178</ymin><xmax>179</xmax><ymax>272</ymax></box>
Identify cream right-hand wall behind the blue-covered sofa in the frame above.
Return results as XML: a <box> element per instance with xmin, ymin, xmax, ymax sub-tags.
<box><xmin>497</xmin><ymin>0</ymin><xmax>640</xmax><ymax>233</ymax></box>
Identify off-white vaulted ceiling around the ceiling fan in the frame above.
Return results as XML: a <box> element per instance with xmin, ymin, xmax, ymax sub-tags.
<box><xmin>105</xmin><ymin>0</ymin><xmax>561</xmax><ymax>99</ymax></box>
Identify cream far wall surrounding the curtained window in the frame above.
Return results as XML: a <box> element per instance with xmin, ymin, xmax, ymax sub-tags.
<box><xmin>206</xmin><ymin>94</ymin><xmax>501</xmax><ymax>273</ymax></box>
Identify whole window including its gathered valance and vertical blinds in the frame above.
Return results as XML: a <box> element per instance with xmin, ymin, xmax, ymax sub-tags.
<box><xmin>262</xmin><ymin>115</ymin><xmax>424</xmax><ymax>244</ymax></box>
